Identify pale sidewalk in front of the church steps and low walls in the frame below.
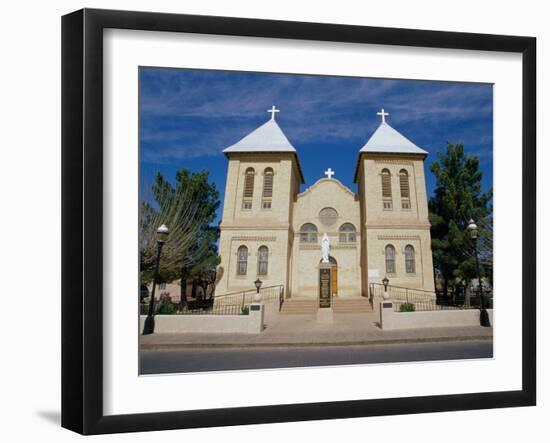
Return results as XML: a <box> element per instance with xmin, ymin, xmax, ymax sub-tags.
<box><xmin>140</xmin><ymin>313</ymin><xmax>493</xmax><ymax>350</ymax></box>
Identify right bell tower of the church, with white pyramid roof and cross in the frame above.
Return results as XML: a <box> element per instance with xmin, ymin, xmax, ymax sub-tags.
<box><xmin>355</xmin><ymin>108</ymin><xmax>434</xmax><ymax>291</ymax></box>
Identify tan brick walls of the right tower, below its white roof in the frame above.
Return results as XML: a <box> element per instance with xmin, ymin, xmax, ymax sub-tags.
<box><xmin>356</xmin><ymin>153</ymin><xmax>434</xmax><ymax>291</ymax></box>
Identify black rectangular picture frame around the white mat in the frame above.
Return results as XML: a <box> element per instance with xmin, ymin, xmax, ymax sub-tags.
<box><xmin>62</xmin><ymin>9</ymin><xmax>536</xmax><ymax>434</ymax></box>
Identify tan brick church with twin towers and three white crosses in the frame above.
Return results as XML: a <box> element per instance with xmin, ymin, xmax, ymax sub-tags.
<box><xmin>216</xmin><ymin>107</ymin><xmax>434</xmax><ymax>299</ymax></box>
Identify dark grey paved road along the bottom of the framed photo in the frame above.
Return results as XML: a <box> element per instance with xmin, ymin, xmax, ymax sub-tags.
<box><xmin>140</xmin><ymin>340</ymin><xmax>493</xmax><ymax>374</ymax></box>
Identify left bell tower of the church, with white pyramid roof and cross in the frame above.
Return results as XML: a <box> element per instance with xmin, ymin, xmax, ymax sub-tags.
<box><xmin>216</xmin><ymin>106</ymin><xmax>304</xmax><ymax>295</ymax></box>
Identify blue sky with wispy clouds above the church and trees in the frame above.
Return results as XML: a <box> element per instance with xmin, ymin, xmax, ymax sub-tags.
<box><xmin>139</xmin><ymin>67</ymin><xmax>493</xmax><ymax>222</ymax></box>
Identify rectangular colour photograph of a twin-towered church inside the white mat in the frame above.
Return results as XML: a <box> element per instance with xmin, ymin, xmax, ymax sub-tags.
<box><xmin>137</xmin><ymin>67</ymin><xmax>494</xmax><ymax>374</ymax></box>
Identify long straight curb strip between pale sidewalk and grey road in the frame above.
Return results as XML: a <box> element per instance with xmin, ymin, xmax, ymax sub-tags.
<box><xmin>139</xmin><ymin>335</ymin><xmax>493</xmax><ymax>351</ymax></box>
